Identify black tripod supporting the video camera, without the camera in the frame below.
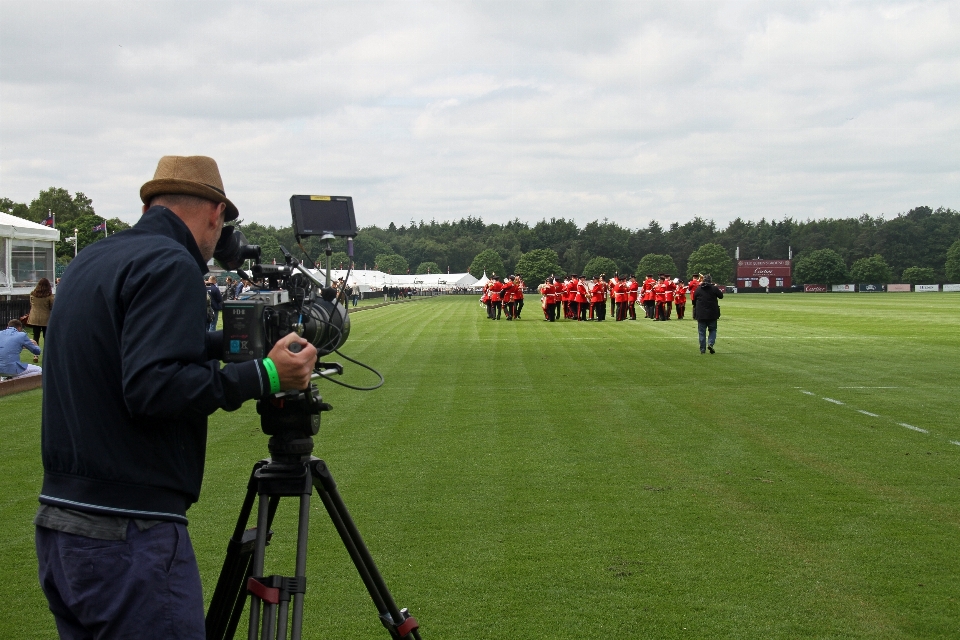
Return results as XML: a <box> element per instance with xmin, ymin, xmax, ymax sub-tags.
<box><xmin>206</xmin><ymin>378</ymin><xmax>420</xmax><ymax>640</ymax></box>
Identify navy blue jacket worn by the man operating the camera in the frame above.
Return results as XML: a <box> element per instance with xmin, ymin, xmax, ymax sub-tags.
<box><xmin>40</xmin><ymin>207</ymin><xmax>269</xmax><ymax>522</ymax></box>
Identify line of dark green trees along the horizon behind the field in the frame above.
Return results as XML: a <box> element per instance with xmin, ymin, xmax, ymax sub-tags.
<box><xmin>0</xmin><ymin>187</ymin><xmax>960</xmax><ymax>282</ymax></box>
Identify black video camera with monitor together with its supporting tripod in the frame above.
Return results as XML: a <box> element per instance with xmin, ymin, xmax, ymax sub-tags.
<box><xmin>206</xmin><ymin>195</ymin><xmax>420</xmax><ymax>640</ymax></box>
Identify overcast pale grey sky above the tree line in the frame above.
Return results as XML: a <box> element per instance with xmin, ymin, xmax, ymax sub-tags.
<box><xmin>0</xmin><ymin>0</ymin><xmax>960</xmax><ymax>228</ymax></box>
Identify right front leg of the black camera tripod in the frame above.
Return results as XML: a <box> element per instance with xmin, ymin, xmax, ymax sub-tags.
<box><xmin>311</xmin><ymin>459</ymin><xmax>420</xmax><ymax>640</ymax></box>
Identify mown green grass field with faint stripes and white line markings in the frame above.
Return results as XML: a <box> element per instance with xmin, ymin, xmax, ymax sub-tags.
<box><xmin>0</xmin><ymin>294</ymin><xmax>960</xmax><ymax>640</ymax></box>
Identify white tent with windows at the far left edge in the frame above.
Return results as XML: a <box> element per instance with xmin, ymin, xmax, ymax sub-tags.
<box><xmin>0</xmin><ymin>212</ymin><xmax>60</xmax><ymax>295</ymax></box>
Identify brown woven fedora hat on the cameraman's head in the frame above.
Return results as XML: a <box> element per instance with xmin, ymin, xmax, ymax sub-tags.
<box><xmin>140</xmin><ymin>156</ymin><xmax>240</xmax><ymax>220</ymax></box>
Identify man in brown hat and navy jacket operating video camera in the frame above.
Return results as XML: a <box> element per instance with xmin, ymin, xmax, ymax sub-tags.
<box><xmin>34</xmin><ymin>156</ymin><xmax>317</xmax><ymax>639</ymax></box>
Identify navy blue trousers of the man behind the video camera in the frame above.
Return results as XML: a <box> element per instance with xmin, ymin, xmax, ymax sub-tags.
<box><xmin>36</xmin><ymin>522</ymin><xmax>206</xmax><ymax>640</ymax></box>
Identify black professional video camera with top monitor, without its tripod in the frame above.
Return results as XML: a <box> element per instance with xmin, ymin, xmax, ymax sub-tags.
<box><xmin>213</xmin><ymin>195</ymin><xmax>357</xmax><ymax>362</ymax></box>
